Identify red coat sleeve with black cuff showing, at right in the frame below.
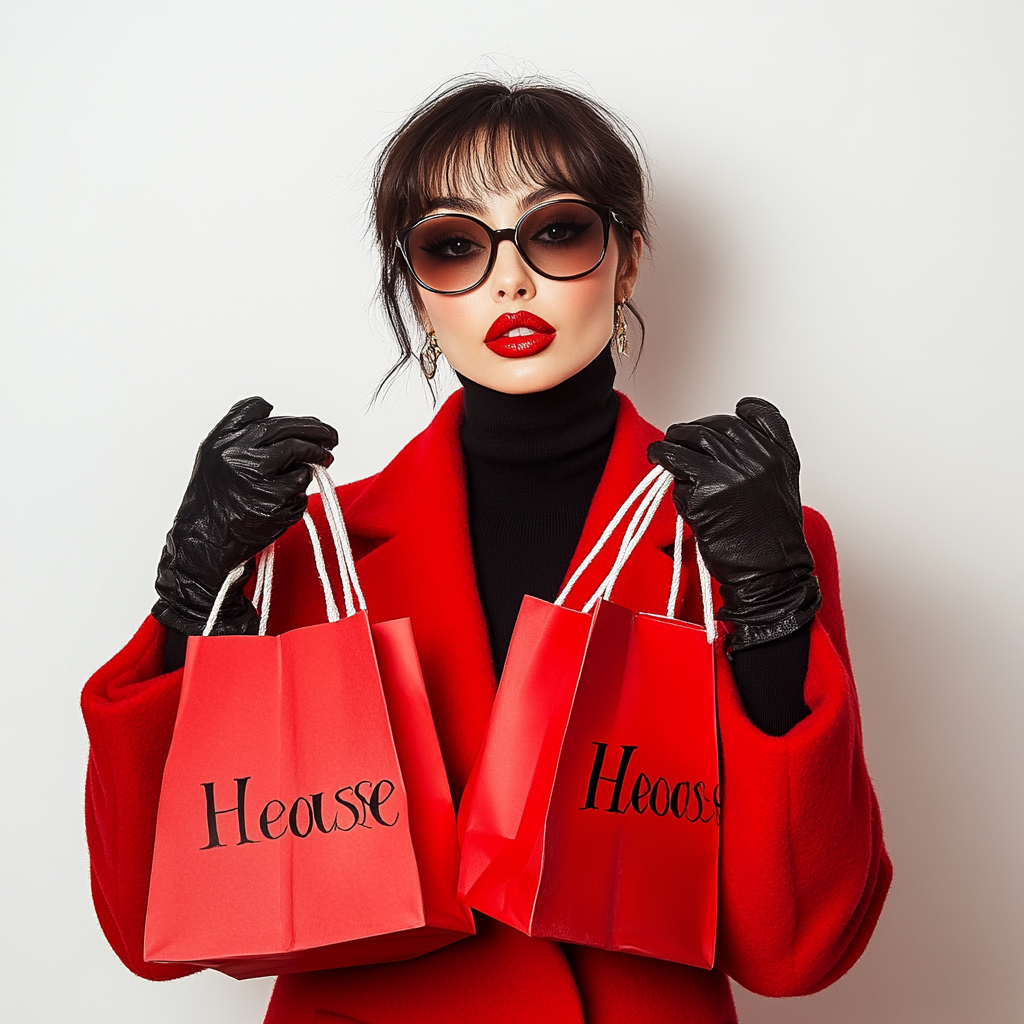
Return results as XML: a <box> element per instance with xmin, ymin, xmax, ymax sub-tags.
<box><xmin>718</xmin><ymin>509</ymin><xmax>892</xmax><ymax>995</ymax></box>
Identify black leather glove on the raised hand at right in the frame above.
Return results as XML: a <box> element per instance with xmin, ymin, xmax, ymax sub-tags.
<box><xmin>647</xmin><ymin>398</ymin><xmax>821</xmax><ymax>650</ymax></box>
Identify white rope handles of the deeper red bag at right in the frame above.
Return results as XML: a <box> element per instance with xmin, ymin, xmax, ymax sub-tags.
<box><xmin>555</xmin><ymin>466</ymin><xmax>718</xmax><ymax>643</ymax></box>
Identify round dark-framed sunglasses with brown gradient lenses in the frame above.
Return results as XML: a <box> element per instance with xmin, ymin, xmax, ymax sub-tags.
<box><xmin>395</xmin><ymin>199</ymin><xmax>626</xmax><ymax>295</ymax></box>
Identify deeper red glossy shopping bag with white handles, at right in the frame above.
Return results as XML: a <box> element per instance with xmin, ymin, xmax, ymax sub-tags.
<box><xmin>459</xmin><ymin>470</ymin><xmax>721</xmax><ymax>968</ymax></box>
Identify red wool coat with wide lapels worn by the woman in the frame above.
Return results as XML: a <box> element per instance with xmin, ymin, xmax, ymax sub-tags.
<box><xmin>82</xmin><ymin>392</ymin><xmax>892</xmax><ymax>1024</ymax></box>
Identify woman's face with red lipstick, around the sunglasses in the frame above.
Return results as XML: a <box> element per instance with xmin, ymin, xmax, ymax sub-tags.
<box><xmin>414</xmin><ymin>187</ymin><xmax>642</xmax><ymax>394</ymax></box>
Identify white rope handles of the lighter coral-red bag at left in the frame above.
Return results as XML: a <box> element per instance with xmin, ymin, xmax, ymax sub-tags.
<box><xmin>203</xmin><ymin>464</ymin><xmax>367</xmax><ymax>636</ymax></box>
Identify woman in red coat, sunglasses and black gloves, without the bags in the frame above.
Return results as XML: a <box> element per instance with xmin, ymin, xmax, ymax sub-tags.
<box><xmin>83</xmin><ymin>80</ymin><xmax>891</xmax><ymax>1024</ymax></box>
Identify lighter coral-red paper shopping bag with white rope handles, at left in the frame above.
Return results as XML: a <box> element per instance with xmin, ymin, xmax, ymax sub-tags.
<box><xmin>145</xmin><ymin>471</ymin><xmax>474</xmax><ymax>978</ymax></box>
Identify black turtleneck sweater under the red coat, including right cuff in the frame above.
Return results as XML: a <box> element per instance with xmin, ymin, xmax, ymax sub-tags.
<box><xmin>459</xmin><ymin>346</ymin><xmax>810</xmax><ymax>736</ymax></box>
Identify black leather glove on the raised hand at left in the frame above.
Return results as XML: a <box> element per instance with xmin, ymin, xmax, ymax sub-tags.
<box><xmin>153</xmin><ymin>398</ymin><xmax>338</xmax><ymax>635</ymax></box>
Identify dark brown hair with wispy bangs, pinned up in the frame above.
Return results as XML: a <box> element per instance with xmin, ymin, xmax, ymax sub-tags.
<box><xmin>373</xmin><ymin>76</ymin><xmax>649</xmax><ymax>388</ymax></box>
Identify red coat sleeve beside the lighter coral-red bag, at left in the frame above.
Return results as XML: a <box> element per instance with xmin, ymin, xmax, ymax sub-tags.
<box><xmin>82</xmin><ymin>615</ymin><xmax>198</xmax><ymax>981</ymax></box>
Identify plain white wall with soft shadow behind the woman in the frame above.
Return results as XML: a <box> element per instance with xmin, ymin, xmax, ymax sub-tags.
<box><xmin>0</xmin><ymin>0</ymin><xmax>1024</xmax><ymax>1024</ymax></box>
